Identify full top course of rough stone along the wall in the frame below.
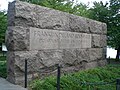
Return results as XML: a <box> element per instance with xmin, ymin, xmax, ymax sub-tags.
<box><xmin>8</xmin><ymin>1</ymin><xmax>107</xmax><ymax>34</ymax></box>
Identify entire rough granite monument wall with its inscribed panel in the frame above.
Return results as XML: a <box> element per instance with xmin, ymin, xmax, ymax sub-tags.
<box><xmin>6</xmin><ymin>1</ymin><xmax>107</xmax><ymax>86</ymax></box>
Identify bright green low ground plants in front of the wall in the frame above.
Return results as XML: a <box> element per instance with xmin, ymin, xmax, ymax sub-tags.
<box><xmin>30</xmin><ymin>65</ymin><xmax>120</xmax><ymax>90</ymax></box>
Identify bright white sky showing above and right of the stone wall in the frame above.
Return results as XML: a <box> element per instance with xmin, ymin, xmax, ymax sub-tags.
<box><xmin>0</xmin><ymin>0</ymin><xmax>117</xmax><ymax>58</ymax></box>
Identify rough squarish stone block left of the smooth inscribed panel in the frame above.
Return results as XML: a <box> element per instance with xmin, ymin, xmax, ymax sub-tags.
<box><xmin>6</xmin><ymin>26</ymin><xmax>29</xmax><ymax>51</ymax></box>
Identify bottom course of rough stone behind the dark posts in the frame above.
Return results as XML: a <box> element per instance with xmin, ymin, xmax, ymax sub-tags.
<box><xmin>7</xmin><ymin>48</ymin><xmax>106</xmax><ymax>86</ymax></box>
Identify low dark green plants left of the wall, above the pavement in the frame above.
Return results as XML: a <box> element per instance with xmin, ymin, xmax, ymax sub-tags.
<box><xmin>0</xmin><ymin>56</ymin><xmax>7</xmax><ymax>78</ymax></box>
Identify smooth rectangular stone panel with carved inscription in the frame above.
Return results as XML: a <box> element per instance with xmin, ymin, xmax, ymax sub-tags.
<box><xmin>30</xmin><ymin>27</ymin><xmax>91</xmax><ymax>50</ymax></box>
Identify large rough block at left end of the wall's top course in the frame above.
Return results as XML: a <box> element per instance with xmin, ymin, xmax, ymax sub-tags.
<box><xmin>9</xmin><ymin>1</ymin><xmax>70</xmax><ymax>30</ymax></box>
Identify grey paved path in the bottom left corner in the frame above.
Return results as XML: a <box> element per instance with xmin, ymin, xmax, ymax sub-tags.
<box><xmin>0</xmin><ymin>78</ymin><xmax>27</xmax><ymax>90</ymax></box>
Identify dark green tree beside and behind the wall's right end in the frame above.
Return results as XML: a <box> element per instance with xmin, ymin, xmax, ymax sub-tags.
<box><xmin>90</xmin><ymin>0</ymin><xmax>120</xmax><ymax>59</ymax></box>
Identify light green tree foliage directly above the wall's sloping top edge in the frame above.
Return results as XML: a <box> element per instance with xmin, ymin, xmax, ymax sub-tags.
<box><xmin>21</xmin><ymin>0</ymin><xmax>89</xmax><ymax>17</ymax></box>
